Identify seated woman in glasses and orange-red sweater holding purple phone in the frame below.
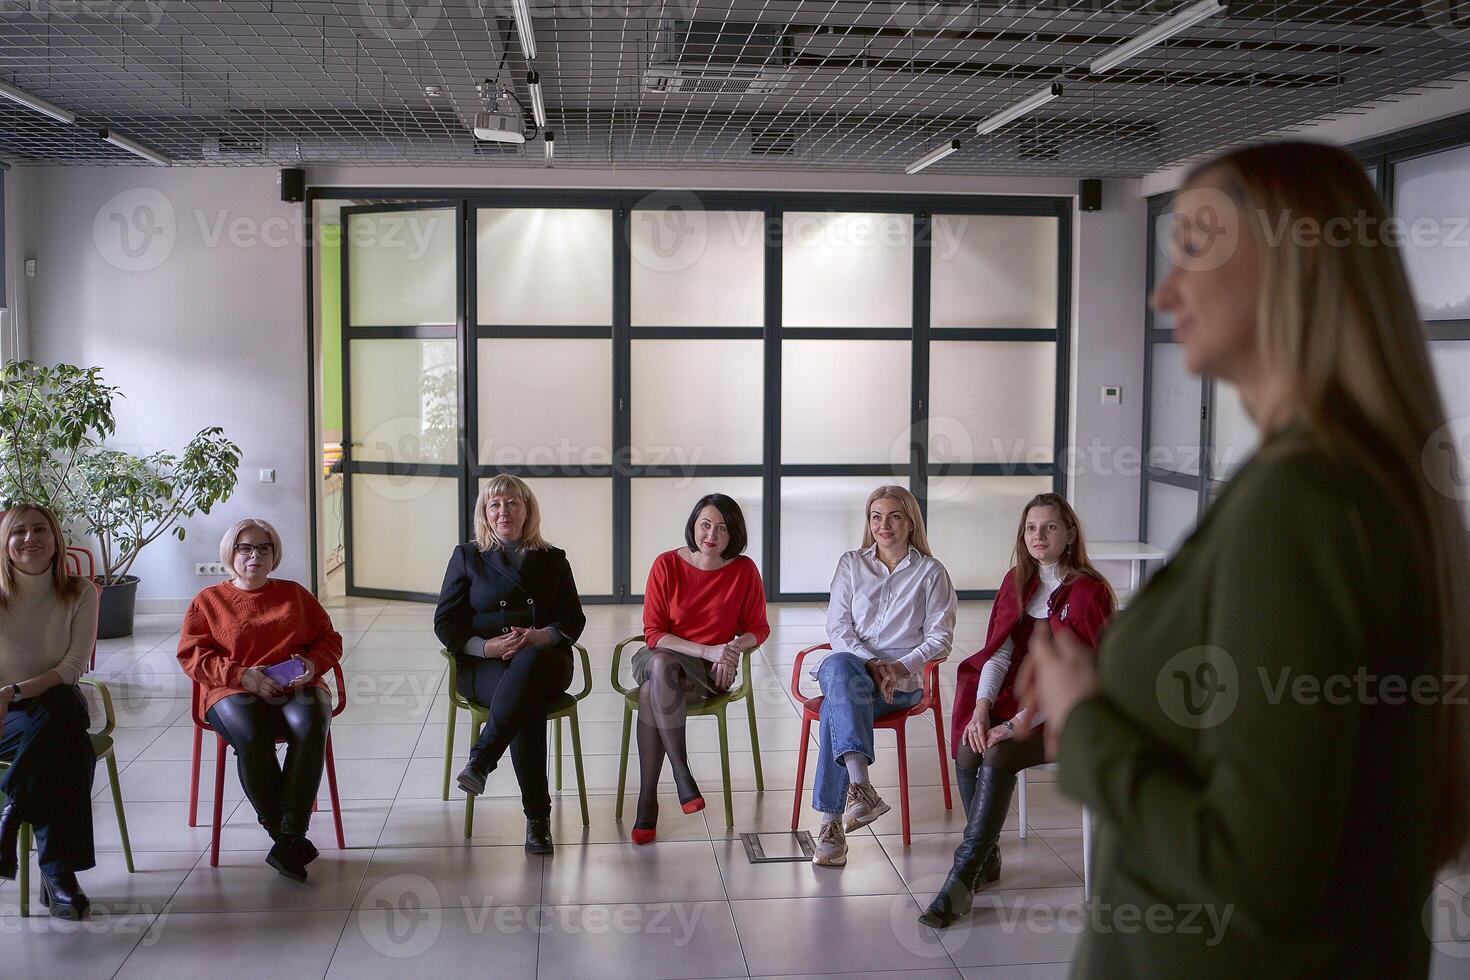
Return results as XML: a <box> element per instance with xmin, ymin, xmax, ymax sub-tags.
<box><xmin>178</xmin><ymin>517</ymin><xmax>343</xmax><ymax>882</ymax></box>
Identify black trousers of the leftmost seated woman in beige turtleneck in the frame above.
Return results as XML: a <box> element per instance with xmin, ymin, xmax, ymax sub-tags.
<box><xmin>0</xmin><ymin>685</ymin><xmax>97</xmax><ymax>877</ymax></box>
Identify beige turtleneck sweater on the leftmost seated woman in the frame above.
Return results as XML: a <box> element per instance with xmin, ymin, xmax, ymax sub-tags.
<box><xmin>0</xmin><ymin>569</ymin><xmax>97</xmax><ymax>686</ymax></box>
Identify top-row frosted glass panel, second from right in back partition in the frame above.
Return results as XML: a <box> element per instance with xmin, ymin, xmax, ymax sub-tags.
<box><xmin>781</xmin><ymin>212</ymin><xmax>914</xmax><ymax>326</ymax></box>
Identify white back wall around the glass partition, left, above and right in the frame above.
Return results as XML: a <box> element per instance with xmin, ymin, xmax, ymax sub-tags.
<box><xmin>16</xmin><ymin>161</ymin><xmax>1145</xmax><ymax>608</ymax></box>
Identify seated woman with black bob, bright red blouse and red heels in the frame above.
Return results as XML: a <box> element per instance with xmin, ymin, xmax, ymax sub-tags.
<box><xmin>632</xmin><ymin>494</ymin><xmax>770</xmax><ymax>843</ymax></box>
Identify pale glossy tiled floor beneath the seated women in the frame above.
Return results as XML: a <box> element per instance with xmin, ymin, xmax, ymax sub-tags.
<box><xmin>11</xmin><ymin>598</ymin><xmax>1470</xmax><ymax>980</ymax></box>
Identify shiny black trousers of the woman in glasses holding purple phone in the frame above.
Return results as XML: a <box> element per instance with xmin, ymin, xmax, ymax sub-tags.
<box><xmin>207</xmin><ymin>688</ymin><xmax>332</xmax><ymax>836</ymax></box>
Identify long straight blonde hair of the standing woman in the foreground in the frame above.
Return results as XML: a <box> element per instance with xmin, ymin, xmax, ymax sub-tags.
<box><xmin>1189</xmin><ymin>143</ymin><xmax>1470</xmax><ymax>861</ymax></box>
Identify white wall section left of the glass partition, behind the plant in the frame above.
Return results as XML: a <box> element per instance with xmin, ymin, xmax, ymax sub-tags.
<box><xmin>16</xmin><ymin>167</ymin><xmax>309</xmax><ymax>610</ymax></box>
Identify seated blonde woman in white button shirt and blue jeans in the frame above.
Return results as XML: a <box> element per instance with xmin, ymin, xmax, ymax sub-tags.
<box><xmin>811</xmin><ymin>486</ymin><xmax>956</xmax><ymax>867</ymax></box>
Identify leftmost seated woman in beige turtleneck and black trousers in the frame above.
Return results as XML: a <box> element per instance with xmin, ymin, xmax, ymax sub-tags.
<box><xmin>0</xmin><ymin>505</ymin><xmax>97</xmax><ymax>918</ymax></box>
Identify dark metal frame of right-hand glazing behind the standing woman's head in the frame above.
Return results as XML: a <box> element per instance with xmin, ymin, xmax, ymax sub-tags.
<box><xmin>1138</xmin><ymin>113</ymin><xmax>1470</xmax><ymax>555</ymax></box>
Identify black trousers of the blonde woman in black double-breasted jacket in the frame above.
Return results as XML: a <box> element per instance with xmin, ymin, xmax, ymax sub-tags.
<box><xmin>456</xmin><ymin>644</ymin><xmax>572</xmax><ymax>820</ymax></box>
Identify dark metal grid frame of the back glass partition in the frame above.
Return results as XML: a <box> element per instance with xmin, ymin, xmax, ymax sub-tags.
<box><xmin>304</xmin><ymin>187</ymin><xmax>1073</xmax><ymax>602</ymax></box>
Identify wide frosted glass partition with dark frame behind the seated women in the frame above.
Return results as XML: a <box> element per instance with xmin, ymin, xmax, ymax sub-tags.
<box><xmin>330</xmin><ymin>190</ymin><xmax>1072</xmax><ymax>601</ymax></box>
